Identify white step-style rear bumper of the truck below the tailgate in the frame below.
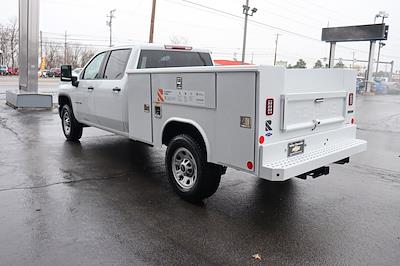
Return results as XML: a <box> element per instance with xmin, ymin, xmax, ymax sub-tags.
<box><xmin>259</xmin><ymin>127</ymin><xmax>367</xmax><ymax>181</ymax></box>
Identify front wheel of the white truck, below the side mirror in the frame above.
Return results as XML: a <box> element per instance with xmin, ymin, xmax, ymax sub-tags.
<box><xmin>61</xmin><ymin>104</ymin><xmax>82</xmax><ymax>141</ymax></box>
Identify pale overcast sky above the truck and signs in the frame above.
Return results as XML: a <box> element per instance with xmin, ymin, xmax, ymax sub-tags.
<box><xmin>0</xmin><ymin>0</ymin><xmax>400</xmax><ymax>70</ymax></box>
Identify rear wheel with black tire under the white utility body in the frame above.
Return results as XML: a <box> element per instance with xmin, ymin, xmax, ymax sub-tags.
<box><xmin>165</xmin><ymin>134</ymin><xmax>222</xmax><ymax>202</ymax></box>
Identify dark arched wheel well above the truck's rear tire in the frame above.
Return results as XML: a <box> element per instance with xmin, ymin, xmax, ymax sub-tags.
<box><xmin>162</xmin><ymin>121</ymin><xmax>207</xmax><ymax>151</ymax></box>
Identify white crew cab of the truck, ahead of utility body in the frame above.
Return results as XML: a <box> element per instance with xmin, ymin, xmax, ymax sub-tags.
<box><xmin>59</xmin><ymin>45</ymin><xmax>213</xmax><ymax>135</ymax></box>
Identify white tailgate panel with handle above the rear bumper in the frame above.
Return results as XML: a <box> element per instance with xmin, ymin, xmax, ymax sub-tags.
<box><xmin>281</xmin><ymin>91</ymin><xmax>347</xmax><ymax>132</ymax></box>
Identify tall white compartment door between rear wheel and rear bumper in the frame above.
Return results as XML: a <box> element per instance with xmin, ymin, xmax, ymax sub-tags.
<box><xmin>216</xmin><ymin>72</ymin><xmax>256</xmax><ymax>170</ymax></box>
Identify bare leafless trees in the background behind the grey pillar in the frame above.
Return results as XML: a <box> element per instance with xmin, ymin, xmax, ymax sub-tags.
<box><xmin>0</xmin><ymin>18</ymin><xmax>96</xmax><ymax>69</ymax></box>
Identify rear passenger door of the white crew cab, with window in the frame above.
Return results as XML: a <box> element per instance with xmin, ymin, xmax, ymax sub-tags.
<box><xmin>94</xmin><ymin>49</ymin><xmax>131</xmax><ymax>132</ymax></box>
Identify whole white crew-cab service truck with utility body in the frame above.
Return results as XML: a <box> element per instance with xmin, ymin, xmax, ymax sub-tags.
<box><xmin>59</xmin><ymin>45</ymin><xmax>366</xmax><ymax>201</ymax></box>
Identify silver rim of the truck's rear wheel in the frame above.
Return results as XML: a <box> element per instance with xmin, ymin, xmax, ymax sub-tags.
<box><xmin>172</xmin><ymin>148</ymin><xmax>197</xmax><ymax>190</ymax></box>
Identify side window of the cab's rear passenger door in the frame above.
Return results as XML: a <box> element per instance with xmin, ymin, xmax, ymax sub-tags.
<box><xmin>104</xmin><ymin>49</ymin><xmax>131</xmax><ymax>79</ymax></box>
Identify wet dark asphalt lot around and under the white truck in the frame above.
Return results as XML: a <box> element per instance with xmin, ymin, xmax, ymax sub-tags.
<box><xmin>0</xmin><ymin>78</ymin><xmax>400</xmax><ymax>265</ymax></box>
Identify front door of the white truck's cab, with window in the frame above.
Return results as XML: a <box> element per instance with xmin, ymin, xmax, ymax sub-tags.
<box><xmin>73</xmin><ymin>52</ymin><xmax>106</xmax><ymax>123</ymax></box>
